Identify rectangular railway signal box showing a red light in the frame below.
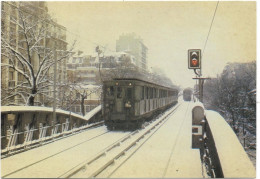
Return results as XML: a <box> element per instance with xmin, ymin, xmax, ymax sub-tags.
<box><xmin>188</xmin><ymin>49</ymin><xmax>201</xmax><ymax>69</ymax></box>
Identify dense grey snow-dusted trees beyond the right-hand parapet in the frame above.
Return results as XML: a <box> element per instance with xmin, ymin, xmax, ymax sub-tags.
<box><xmin>204</xmin><ymin>61</ymin><xmax>256</xmax><ymax>138</ymax></box>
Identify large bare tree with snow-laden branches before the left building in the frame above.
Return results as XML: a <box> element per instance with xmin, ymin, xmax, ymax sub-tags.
<box><xmin>1</xmin><ymin>9</ymin><xmax>72</xmax><ymax>106</ymax></box>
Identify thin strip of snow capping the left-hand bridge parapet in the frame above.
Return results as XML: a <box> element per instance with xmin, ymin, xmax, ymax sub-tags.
<box><xmin>1</xmin><ymin>105</ymin><xmax>101</xmax><ymax>120</ymax></box>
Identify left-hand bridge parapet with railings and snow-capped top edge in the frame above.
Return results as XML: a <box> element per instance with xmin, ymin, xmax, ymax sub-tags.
<box><xmin>1</xmin><ymin>106</ymin><xmax>101</xmax><ymax>154</ymax></box>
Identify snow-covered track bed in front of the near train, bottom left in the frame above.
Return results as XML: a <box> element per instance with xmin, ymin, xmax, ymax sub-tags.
<box><xmin>1</xmin><ymin>126</ymin><xmax>129</xmax><ymax>178</ymax></box>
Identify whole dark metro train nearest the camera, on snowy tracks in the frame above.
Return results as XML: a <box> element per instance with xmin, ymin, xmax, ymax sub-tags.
<box><xmin>102</xmin><ymin>78</ymin><xmax>178</xmax><ymax>130</ymax></box>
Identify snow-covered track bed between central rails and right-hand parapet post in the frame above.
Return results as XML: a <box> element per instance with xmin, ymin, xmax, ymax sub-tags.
<box><xmin>110</xmin><ymin>102</ymin><xmax>203</xmax><ymax>178</ymax></box>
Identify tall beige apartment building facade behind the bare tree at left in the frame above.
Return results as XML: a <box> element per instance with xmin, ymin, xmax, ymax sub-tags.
<box><xmin>1</xmin><ymin>1</ymin><xmax>67</xmax><ymax>106</ymax></box>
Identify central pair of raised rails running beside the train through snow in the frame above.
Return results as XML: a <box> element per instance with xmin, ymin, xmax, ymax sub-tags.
<box><xmin>59</xmin><ymin>104</ymin><xmax>180</xmax><ymax>178</ymax></box>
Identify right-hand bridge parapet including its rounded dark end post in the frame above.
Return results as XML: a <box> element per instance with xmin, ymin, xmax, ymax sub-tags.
<box><xmin>192</xmin><ymin>103</ymin><xmax>256</xmax><ymax>178</ymax></box>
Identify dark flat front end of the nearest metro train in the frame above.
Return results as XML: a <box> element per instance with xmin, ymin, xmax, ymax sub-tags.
<box><xmin>103</xmin><ymin>80</ymin><xmax>136</xmax><ymax>130</ymax></box>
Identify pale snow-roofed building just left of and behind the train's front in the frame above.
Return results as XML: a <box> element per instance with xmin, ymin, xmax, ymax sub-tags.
<box><xmin>67</xmin><ymin>51</ymin><xmax>136</xmax><ymax>114</ymax></box>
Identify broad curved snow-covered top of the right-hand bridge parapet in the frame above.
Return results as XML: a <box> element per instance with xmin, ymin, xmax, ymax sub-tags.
<box><xmin>206</xmin><ymin>110</ymin><xmax>256</xmax><ymax>178</ymax></box>
